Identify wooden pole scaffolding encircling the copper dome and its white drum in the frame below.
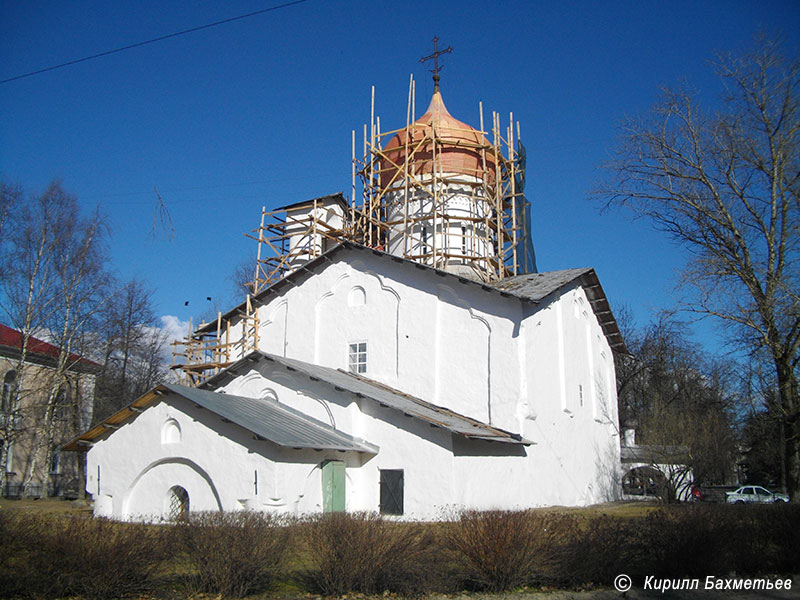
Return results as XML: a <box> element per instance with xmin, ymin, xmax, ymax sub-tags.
<box><xmin>351</xmin><ymin>77</ymin><xmax>530</xmax><ymax>283</ymax></box>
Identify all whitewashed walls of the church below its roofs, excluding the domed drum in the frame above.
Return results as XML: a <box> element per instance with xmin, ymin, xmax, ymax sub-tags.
<box><xmin>87</xmin><ymin>251</ymin><xmax>620</xmax><ymax>519</ymax></box>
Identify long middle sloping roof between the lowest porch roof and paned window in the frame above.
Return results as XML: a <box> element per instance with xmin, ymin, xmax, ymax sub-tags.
<box><xmin>202</xmin><ymin>350</ymin><xmax>531</xmax><ymax>445</ymax></box>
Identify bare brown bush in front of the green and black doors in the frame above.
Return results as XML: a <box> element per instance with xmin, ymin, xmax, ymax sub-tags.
<box><xmin>303</xmin><ymin>513</ymin><xmax>435</xmax><ymax>596</ymax></box>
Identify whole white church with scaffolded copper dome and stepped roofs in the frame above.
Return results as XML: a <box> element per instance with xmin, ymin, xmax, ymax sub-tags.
<box><xmin>65</xmin><ymin>68</ymin><xmax>625</xmax><ymax>520</ymax></box>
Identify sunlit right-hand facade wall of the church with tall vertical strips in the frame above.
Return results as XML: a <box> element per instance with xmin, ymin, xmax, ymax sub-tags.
<box><xmin>520</xmin><ymin>285</ymin><xmax>620</xmax><ymax>505</ymax></box>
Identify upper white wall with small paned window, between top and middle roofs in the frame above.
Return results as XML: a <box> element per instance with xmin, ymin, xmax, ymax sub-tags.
<box><xmin>253</xmin><ymin>252</ymin><xmax>521</xmax><ymax>428</ymax></box>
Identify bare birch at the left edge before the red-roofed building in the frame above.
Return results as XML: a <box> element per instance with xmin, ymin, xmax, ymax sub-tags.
<box><xmin>0</xmin><ymin>182</ymin><xmax>109</xmax><ymax>493</ymax></box>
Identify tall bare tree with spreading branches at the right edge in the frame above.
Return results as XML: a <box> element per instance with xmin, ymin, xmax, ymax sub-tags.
<box><xmin>599</xmin><ymin>36</ymin><xmax>800</xmax><ymax>501</ymax></box>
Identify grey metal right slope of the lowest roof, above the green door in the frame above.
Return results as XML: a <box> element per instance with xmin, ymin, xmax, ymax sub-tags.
<box><xmin>164</xmin><ymin>383</ymin><xmax>378</xmax><ymax>454</ymax></box>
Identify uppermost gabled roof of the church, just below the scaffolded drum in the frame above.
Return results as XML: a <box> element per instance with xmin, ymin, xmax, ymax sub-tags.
<box><xmin>196</xmin><ymin>241</ymin><xmax>628</xmax><ymax>354</ymax></box>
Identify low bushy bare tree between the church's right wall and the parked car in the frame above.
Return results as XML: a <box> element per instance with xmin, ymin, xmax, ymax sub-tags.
<box><xmin>617</xmin><ymin>312</ymin><xmax>742</xmax><ymax>502</ymax></box>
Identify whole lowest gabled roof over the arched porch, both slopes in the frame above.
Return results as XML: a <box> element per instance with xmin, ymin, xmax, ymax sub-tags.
<box><xmin>63</xmin><ymin>384</ymin><xmax>378</xmax><ymax>454</ymax></box>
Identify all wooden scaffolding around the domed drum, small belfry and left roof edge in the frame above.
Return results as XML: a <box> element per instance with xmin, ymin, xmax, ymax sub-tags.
<box><xmin>172</xmin><ymin>77</ymin><xmax>530</xmax><ymax>386</ymax></box>
